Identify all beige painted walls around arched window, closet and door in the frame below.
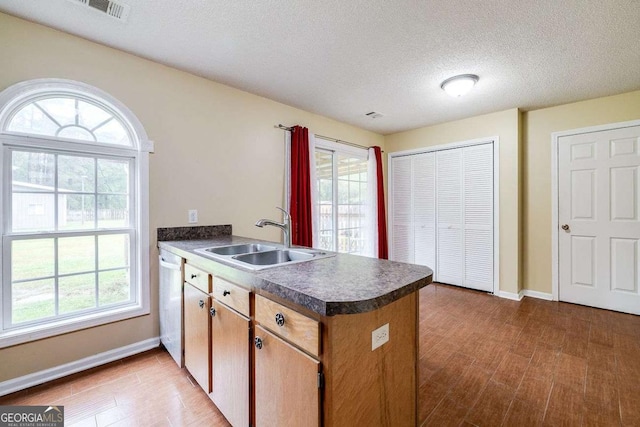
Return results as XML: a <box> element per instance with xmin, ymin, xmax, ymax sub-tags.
<box><xmin>0</xmin><ymin>9</ymin><xmax>640</xmax><ymax>388</ymax></box>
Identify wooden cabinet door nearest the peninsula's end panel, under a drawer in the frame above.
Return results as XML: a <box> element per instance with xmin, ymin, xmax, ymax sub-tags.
<box><xmin>254</xmin><ymin>326</ymin><xmax>320</xmax><ymax>427</ymax></box>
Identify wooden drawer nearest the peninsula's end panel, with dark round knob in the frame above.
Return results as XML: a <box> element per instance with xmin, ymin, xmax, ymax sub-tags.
<box><xmin>255</xmin><ymin>295</ymin><xmax>320</xmax><ymax>356</ymax></box>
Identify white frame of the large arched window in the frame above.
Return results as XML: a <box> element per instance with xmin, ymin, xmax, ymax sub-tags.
<box><xmin>0</xmin><ymin>79</ymin><xmax>153</xmax><ymax>348</ymax></box>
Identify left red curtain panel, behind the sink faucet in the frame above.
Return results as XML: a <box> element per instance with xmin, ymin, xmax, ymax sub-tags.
<box><xmin>289</xmin><ymin>126</ymin><xmax>313</xmax><ymax>247</ymax></box>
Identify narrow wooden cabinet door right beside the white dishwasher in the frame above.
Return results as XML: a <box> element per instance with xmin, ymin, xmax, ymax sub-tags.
<box><xmin>184</xmin><ymin>283</ymin><xmax>211</xmax><ymax>393</ymax></box>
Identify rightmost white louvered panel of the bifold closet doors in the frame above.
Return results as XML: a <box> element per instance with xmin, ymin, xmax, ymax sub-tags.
<box><xmin>462</xmin><ymin>144</ymin><xmax>493</xmax><ymax>292</ymax></box>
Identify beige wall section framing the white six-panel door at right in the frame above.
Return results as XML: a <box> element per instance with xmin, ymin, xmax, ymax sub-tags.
<box><xmin>522</xmin><ymin>91</ymin><xmax>640</xmax><ymax>293</ymax></box>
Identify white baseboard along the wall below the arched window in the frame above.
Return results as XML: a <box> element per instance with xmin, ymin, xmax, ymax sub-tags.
<box><xmin>0</xmin><ymin>337</ymin><xmax>160</xmax><ymax>396</ymax></box>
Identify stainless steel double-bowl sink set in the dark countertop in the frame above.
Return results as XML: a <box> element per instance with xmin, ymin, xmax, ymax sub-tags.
<box><xmin>195</xmin><ymin>243</ymin><xmax>335</xmax><ymax>270</ymax></box>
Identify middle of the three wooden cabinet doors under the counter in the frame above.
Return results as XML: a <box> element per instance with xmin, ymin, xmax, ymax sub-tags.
<box><xmin>209</xmin><ymin>301</ymin><xmax>250</xmax><ymax>426</ymax></box>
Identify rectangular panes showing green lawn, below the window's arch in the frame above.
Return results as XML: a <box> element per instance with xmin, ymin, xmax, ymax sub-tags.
<box><xmin>11</xmin><ymin>151</ymin><xmax>131</xmax><ymax>324</ymax></box>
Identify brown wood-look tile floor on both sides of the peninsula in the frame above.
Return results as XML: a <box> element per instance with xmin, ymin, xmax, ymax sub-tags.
<box><xmin>0</xmin><ymin>284</ymin><xmax>640</xmax><ymax>427</ymax></box>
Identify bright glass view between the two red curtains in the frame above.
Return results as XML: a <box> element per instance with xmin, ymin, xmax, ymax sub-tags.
<box><xmin>315</xmin><ymin>149</ymin><xmax>368</xmax><ymax>255</ymax></box>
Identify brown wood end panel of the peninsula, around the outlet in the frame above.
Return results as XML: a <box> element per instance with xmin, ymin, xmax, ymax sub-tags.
<box><xmin>322</xmin><ymin>293</ymin><xmax>418</xmax><ymax>427</ymax></box>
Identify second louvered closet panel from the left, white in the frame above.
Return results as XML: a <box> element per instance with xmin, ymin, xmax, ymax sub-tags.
<box><xmin>412</xmin><ymin>152</ymin><xmax>437</xmax><ymax>270</ymax></box>
